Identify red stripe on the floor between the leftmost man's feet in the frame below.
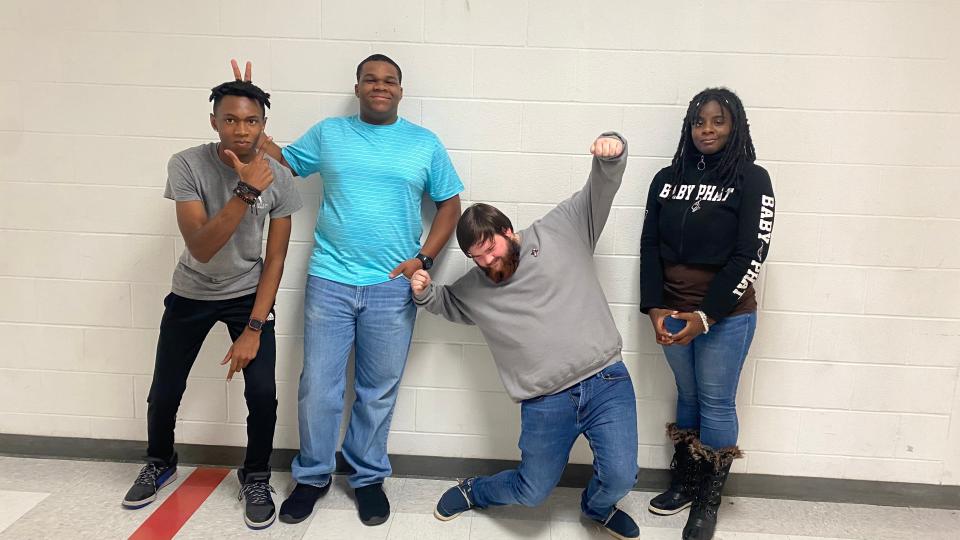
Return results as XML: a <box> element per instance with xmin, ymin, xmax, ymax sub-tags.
<box><xmin>130</xmin><ymin>468</ymin><xmax>230</xmax><ymax>540</ymax></box>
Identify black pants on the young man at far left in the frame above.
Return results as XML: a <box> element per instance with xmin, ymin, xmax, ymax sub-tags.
<box><xmin>147</xmin><ymin>293</ymin><xmax>277</xmax><ymax>473</ymax></box>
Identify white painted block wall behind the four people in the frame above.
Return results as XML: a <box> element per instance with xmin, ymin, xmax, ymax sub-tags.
<box><xmin>0</xmin><ymin>0</ymin><xmax>960</xmax><ymax>485</ymax></box>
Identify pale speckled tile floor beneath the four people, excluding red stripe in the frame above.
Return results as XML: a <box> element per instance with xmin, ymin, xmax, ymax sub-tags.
<box><xmin>0</xmin><ymin>457</ymin><xmax>960</xmax><ymax>540</ymax></box>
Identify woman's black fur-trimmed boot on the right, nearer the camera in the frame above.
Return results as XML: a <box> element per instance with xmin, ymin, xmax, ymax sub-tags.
<box><xmin>683</xmin><ymin>439</ymin><xmax>743</xmax><ymax>540</ymax></box>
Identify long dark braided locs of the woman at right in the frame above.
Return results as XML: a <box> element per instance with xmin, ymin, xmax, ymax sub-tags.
<box><xmin>671</xmin><ymin>88</ymin><xmax>757</xmax><ymax>187</ymax></box>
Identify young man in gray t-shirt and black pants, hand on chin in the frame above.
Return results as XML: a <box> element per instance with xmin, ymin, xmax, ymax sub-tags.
<box><xmin>123</xmin><ymin>73</ymin><xmax>302</xmax><ymax>529</ymax></box>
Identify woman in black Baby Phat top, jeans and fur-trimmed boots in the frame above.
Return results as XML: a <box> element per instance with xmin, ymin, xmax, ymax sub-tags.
<box><xmin>640</xmin><ymin>88</ymin><xmax>774</xmax><ymax>539</ymax></box>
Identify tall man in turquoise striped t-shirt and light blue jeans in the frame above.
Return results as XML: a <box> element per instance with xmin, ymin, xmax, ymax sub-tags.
<box><xmin>253</xmin><ymin>54</ymin><xmax>463</xmax><ymax>525</ymax></box>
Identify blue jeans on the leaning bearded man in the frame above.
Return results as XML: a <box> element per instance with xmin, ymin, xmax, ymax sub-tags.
<box><xmin>473</xmin><ymin>362</ymin><xmax>637</xmax><ymax>520</ymax></box>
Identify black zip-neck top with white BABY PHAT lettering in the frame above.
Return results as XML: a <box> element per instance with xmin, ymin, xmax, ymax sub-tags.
<box><xmin>640</xmin><ymin>153</ymin><xmax>774</xmax><ymax>321</ymax></box>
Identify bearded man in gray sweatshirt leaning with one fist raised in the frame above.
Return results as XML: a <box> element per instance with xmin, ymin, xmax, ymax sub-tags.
<box><xmin>410</xmin><ymin>132</ymin><xmax>640</xmax><ymax>538</ymax></box>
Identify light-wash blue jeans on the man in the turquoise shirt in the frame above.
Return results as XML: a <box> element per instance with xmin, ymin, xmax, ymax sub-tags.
<box><xmin>292</xmin><ymin>276</ymin><xmax>417</xmax><ymax>488</ymax></box>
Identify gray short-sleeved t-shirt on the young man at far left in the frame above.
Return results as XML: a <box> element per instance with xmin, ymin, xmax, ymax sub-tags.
<box><xmin>163</xmin><ymin>143</ymin><xmax>303</xmax><ymax>300</ymax></box>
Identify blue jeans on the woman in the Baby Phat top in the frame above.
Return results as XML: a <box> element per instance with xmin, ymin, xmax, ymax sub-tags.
<box><xmin>663</xmin><ymin>312</ymin><xmax>757</xmax><ymax>449</ymax></box>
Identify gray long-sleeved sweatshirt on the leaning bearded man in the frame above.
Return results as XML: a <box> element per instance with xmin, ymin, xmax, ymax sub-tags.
<box><xmin>414</xmin><ymin>133</ymin><xmax>627</xmax><ymax>401</ymax></box>
